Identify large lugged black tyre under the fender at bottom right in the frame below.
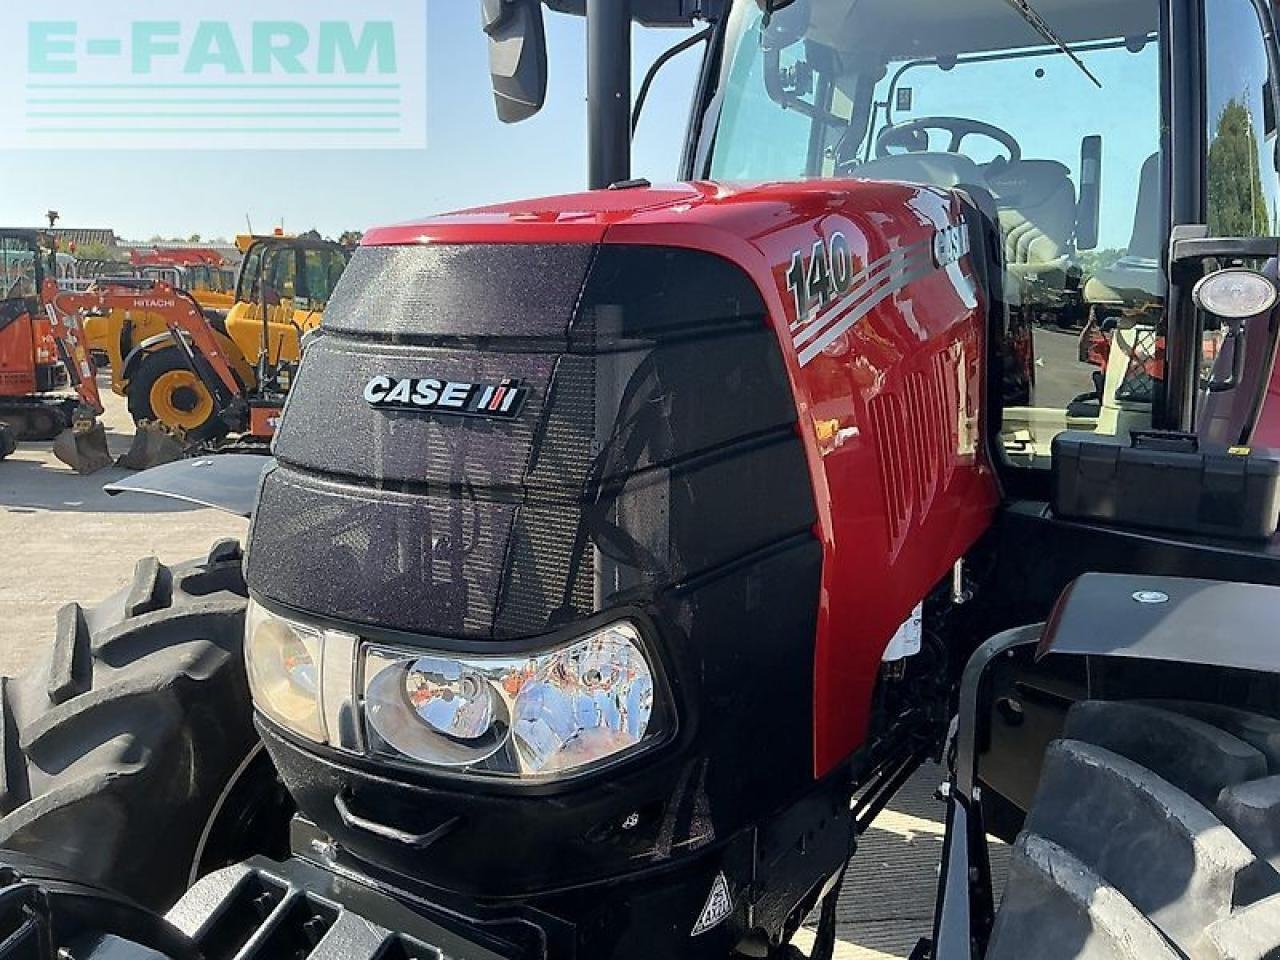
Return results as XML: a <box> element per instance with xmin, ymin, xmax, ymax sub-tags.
<box><xmin>987</xmin><ymin>700</ymin><xmax>1280</xmax><ymax>960</ymax></box>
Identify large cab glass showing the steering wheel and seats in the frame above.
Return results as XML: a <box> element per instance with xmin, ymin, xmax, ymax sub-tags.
<box><xmin>705</xmin><ymin>0</ymin><xmax>1165</xmax><ymax>461</ymax></box>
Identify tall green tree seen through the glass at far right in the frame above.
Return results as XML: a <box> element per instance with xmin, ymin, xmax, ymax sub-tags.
<box><xmin>1208</xmin><ymin>100</ymin><xmax>1271</xmax><ymax>237</ymax></box>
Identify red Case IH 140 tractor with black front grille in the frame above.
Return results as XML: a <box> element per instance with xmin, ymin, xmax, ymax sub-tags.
<box><xmin>0</xmin><ymin>0</ymin><xmax>1280</xmax><ymax>960</ymax></box>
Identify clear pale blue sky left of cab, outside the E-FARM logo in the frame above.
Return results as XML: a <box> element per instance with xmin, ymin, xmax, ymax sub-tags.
<box><xmin>0</xmin><ymin>6</ymin><xmax>701</xmax><ymax>239</ymax></box>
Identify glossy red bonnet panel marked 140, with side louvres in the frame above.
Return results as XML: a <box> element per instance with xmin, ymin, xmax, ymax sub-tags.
<box><xmin>365</xmin><ymin>180</ymin><xmax>998</xmax><ymax>776</ymax></box>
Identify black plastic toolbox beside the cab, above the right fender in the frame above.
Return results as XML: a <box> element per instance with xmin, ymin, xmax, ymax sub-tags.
<box><xmin>1053</xmin><ymin>430</ymin><xmax>1280</xmax><ymax>540</ymax></box>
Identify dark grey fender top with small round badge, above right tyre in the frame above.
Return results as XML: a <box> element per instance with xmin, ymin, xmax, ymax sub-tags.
<box><xmin>1036</xmin><ymin>573</ymin><xmax>1280</xmax><ymax>673</ymax></box>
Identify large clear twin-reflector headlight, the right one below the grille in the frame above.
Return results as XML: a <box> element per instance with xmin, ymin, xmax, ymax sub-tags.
<box><xmin>364</xmin><ymin>622</ymin><xmax>662</xmax><ymax>778</ymax></box>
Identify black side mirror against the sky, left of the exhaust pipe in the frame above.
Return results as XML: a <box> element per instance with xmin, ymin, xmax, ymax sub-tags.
<box><xmin>481</xmin><ymin>0</ymin><xmax>547</xmax><ymax>123</ymax></box>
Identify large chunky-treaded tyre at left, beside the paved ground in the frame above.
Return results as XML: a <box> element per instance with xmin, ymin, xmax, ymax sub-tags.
<box><xmin>0</xmin><ymin>540</ymin><xmax>265</xmax><ymax>910</ymax></box>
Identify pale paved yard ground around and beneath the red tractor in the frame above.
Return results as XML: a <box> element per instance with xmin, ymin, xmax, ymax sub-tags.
<box><xmin>0</xmin><ymin>384</ymin><xmax>1007</xmax><ymax>960</ymax></box>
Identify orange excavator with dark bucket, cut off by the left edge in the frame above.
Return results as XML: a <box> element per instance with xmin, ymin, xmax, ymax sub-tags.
<box><xmin>0</xmin><ymin>229</ymin><xmax>109</xmax><ymax>466</ymax></box>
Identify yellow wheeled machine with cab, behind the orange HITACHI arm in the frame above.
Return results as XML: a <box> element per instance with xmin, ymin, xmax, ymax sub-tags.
<box><xmin>87</xmin><ymin>236</ymin><xmax>349</xmax><ymax>442</ymax></box>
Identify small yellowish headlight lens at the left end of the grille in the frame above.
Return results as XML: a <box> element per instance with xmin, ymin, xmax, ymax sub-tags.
<box><xmin>244</xmin><ymin>603</ymin><xmax>325</xmax><ymax>742</ymax></box>
